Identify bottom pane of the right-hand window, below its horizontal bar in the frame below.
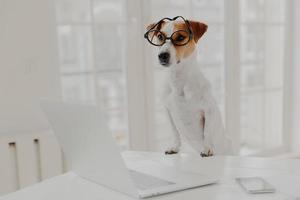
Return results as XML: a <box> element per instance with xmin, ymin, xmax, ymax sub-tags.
<box><xmin>241</xmin><ymin>89</ymin><xmax>283</xmax><ymax>155</ymax></box>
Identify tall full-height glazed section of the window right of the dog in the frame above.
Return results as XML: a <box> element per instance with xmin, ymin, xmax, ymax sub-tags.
<box><xmin>240</xmin><ymin>0</ymin><xmax>285</xmax><ymax>154</ymax></box>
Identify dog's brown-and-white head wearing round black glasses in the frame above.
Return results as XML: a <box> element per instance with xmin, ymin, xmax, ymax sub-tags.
<box><xmin>145</xmin><ymin>16</ymin><xmax>207</xmax><ymax>67</ymax></box>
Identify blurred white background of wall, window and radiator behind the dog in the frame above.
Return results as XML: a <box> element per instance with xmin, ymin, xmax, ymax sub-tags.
<box><xmin>0</xmin><ymin>0</ymin><xmax>300</xmax><ymax>194</ymax></box>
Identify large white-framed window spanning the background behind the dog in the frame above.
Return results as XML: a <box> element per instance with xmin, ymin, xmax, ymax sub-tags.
<box><xmin>56</xmin><ymin>0</ymin><xmax>288</xmax><ymax>155</ymax></box>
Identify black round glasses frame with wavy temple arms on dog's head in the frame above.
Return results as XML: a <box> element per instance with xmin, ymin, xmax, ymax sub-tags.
<box><xmin>144</xmin><ymin>16</ymin><xmax>193</xmax><ymax>46</ymax></box>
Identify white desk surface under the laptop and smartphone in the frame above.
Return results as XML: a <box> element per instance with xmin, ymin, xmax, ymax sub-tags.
<box><xmin>0</xmin><ymin>152</ymin><xmax>300</xmax><ymax>200</ymax></box>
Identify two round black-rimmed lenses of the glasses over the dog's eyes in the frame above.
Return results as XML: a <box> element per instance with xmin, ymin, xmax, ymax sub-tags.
<box><xmin>145</xmin><ymin>30</ymin><xmax>191</xmax><ymax>46</ymax></box>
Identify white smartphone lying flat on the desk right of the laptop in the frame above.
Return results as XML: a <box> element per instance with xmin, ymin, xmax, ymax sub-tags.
<box><xmin>235</xmin><ymin>177</ymin><xmax>276</xmax><ymax>194</ymax></box>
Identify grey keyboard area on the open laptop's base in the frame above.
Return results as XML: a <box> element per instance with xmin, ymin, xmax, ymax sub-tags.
<box><xmin>129</xmin><ymin>170</ymin><xmax>175</xmax><ymax>190</ymax></box>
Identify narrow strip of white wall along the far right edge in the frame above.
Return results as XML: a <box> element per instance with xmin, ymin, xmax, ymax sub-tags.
<box><xmin>292</xmin><ymin>0</ymin><xmax>300</xmax><ymax>152</ymax></box>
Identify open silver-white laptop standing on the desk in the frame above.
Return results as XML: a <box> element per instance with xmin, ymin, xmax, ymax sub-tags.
<box><xmin>41</xmin><ymin>100</ymin><xmax>217</xmax><ymax>198</ymax></box>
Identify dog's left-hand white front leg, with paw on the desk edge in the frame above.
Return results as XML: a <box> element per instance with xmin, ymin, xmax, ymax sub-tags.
<box><xmin>165</xmin><ymin>108</ymin><xmax>181</xmax><ymax>154</ymax></box>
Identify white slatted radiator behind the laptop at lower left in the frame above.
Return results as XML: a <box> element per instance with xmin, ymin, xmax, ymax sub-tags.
<box><xmin>0</xmin><ymin>131</ymin><xmax>63</xmax><ymax>196</ymax></box>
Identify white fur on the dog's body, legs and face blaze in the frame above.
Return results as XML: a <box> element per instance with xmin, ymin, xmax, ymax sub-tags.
<box><xmin>158</xmin><ymin>22</ymin><xmax>232</xmax><ymax>155</ymax></box>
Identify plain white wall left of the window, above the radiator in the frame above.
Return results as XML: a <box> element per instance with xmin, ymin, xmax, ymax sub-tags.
<box><xmin>0</xmin><ymin>0</ymin><xmax>60</xmax><ymax>134</ymax></box>
